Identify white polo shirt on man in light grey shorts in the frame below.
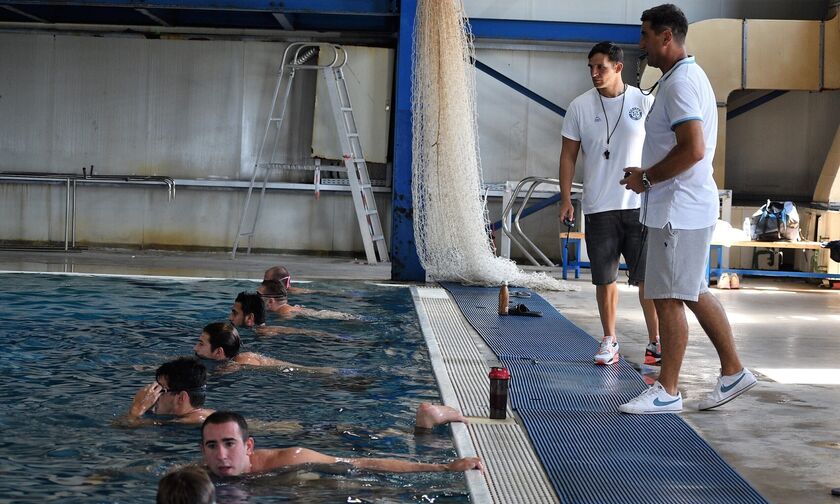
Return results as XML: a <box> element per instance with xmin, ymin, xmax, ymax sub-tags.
<box><xmin>640</xmin><ymin>56</ymin><xmax>719</xmax><ymax>229</ymax></box>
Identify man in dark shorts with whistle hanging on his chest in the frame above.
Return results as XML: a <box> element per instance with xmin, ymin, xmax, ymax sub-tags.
<box><xmin>560</xmin><ymin>42</ymin><xmax>659</xmax><ymax>365</ymax></box>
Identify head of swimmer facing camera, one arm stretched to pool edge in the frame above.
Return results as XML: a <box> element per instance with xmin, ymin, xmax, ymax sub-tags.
<box><xmin>201</xmin><ymin>411</ymin><xmax>254</xmax><ymax>476</ymax></box>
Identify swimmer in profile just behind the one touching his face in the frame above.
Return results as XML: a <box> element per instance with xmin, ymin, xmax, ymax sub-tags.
<box><xmin>193</xmin><ymin>322</ymin><xmax>336</xmax><ymax>373</ymax></box>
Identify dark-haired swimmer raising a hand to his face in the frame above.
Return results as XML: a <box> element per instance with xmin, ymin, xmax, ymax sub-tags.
<box><xmin>118</xmin><ymin>357</ymin><xmax>213</xmax><ymax>426</ymax></box>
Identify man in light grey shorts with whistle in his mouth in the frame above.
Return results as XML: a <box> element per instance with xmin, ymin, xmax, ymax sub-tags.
<box><xmin>618</xmin><ymin>4</ymin><xmax>756</xmax><ymax>414</ymax></box>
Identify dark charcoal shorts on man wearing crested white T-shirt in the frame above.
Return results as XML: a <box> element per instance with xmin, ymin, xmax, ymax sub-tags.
<box><xmin>585</xmin><ymin>209</ymin><xmax>645</xmax><ymax>285</ymax></box>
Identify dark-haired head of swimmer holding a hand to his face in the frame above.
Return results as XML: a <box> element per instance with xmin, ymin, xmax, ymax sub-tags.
<box><xmin>153</xmin><ymin>357</ymin><xmax>207</xmax><ymax>415</ymax></box>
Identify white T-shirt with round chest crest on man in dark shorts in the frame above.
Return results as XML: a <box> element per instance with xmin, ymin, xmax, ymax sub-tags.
<box><xmin>561</xmin><ymin>86</ymin><xmax>653</xmax><ymax>214</ymax></box>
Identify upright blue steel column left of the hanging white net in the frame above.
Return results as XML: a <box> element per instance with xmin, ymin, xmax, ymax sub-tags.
<box><xmin>391</xmin><ymin>0</ymin><xmax>426</xmax><ymax>281</ymax></box>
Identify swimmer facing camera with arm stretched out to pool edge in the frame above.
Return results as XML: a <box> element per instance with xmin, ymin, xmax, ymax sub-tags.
<box><xmin>201</xmin><ymin>411</ymin><xmax>483</xmax><ymax>477</ymax></box>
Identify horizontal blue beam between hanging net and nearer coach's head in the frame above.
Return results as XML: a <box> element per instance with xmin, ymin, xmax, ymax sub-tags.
<box><xmin>469</xmin><ymin>18</ymin><xmax>641</xmax><ymax>44</ymax></box>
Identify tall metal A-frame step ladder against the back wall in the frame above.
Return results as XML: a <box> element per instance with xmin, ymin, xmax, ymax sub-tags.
<box><xmin>231</xmin><ymin>42</ymin><xmax>390</xmax><ymax>264</ymax></box>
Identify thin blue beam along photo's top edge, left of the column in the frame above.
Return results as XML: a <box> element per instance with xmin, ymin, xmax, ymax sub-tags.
<box><xmin>3</xmin><ymin>0</ymin><xmax>398</xmax><ymax>16</ymax></box>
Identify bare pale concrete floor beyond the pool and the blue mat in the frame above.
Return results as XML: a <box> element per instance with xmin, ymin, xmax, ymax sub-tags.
<box><xmin>0</xmin><ymin>250</ymin><xmax>840</xmax><ymax>504</ymax></box>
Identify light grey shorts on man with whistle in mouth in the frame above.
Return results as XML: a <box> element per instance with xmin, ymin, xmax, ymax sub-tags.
<box><xmin>645</xmin><ymin>224</ymin><xmax>715</xmax><ymax>301</ymax></box>
